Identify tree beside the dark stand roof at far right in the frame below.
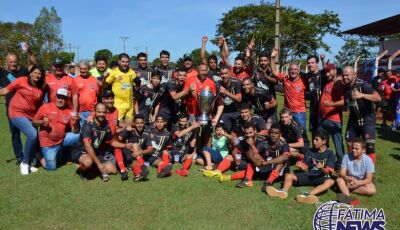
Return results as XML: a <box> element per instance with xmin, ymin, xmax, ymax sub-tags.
<box><xmin>335</xmin><ymin>37</ymin><xmax>379</xmax><ymax>66</ymax></box>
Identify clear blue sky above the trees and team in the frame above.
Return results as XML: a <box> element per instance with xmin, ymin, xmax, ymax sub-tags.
<box><xmin>0</xmin><ymin>0</ymin><xmax>400</xmax><ymax>60</ymax></box>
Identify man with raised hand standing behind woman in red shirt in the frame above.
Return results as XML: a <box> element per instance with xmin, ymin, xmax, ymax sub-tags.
<box><xmin>0</xmin><ymin>47</ymin><xmax>37</xmax><ymax>165</ymax></box>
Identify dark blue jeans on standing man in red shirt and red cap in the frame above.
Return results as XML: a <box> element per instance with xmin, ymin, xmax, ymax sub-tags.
<box><xmin>318</xmin><ymin>119</ymin><xmax>344</xmax><ymax>168</ymax></box>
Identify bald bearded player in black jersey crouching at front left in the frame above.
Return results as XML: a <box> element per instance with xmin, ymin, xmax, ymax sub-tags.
<box><xmin>71</xmin><ymin>103</ymin><xmax>132</xmax><ymax>182</ymax></box>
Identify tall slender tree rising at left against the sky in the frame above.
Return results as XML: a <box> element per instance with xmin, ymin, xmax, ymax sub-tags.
<box><xmin>33</xmin><ymin>7</ymin><xmax>63</xmax><ymax>66</ymax></box>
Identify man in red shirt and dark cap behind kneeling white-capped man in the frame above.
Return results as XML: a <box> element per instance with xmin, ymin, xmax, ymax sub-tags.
<box><xmin>46</xmin><ymin>57</ymin><xmax>79</xmax><ymax>113</ymax></box>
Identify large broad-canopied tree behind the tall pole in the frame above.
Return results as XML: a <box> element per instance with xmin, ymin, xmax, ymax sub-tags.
<box><xmin>213</xmin><ymin>2</ymin><xmax>340</xmax><ymax>62</ymax></box>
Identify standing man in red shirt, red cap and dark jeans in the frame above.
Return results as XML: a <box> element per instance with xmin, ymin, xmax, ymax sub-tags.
<box><xmin>317</xmin><ymin>64</ymin><xmax>344</xmax><ymax>169</ymax></box>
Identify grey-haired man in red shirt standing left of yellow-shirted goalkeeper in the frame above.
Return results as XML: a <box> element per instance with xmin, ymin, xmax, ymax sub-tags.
<box><xmin>74</xmin><ymin>61</ymin><xmax>99</xmax><ymax>127</ymax></box>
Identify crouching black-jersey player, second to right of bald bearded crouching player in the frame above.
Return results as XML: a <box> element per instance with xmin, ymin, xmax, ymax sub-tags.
<box><xmin>144</xmin><ymin>115</ymin><xmax>172</xmax><ymax>178</ymax></box>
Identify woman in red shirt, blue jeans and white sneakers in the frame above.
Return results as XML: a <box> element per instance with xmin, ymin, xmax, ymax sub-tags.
<box><xmin>0</xmin><ymin>65</ymin><xmax>46</xmax><ymax>175</ymax></box>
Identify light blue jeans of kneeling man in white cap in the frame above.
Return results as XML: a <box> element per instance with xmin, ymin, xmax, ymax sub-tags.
<box><xmin>42</xmin><ymin>132</ymin><xmax>79</xmax><ymax>170</ymax></box>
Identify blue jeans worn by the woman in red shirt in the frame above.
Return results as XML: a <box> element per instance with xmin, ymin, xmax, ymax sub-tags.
<box><xmin>11</xmin><ymin>117</ymin><xmax>37</xmax><ymax>164</ymax></box>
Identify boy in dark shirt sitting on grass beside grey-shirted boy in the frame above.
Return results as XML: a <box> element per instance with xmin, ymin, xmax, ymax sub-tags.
<box><xmin>266</xmin><ymin>132</ymin><xmax>335</xmax><ymax>204</ymax></box>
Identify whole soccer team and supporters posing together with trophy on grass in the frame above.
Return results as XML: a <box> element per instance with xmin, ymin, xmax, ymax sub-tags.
<box><xmin>0</xmin><ymin>36</ymin><xmax>381</xmax><ymax>206</ymax></box>
